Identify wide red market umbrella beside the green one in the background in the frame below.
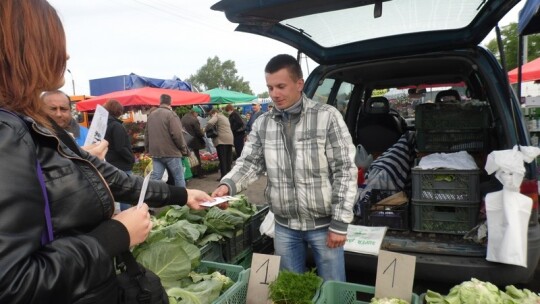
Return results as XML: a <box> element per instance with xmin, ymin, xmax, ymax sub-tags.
<box><xmin>76</xmin><ymin>87</ymin><xmax>210</xmax><ymax>111</ymax></box>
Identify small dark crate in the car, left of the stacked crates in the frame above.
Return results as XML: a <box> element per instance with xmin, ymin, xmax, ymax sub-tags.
<box><xmin>362</xmin><ymin>189</ymin><xmax>409</xmax><ymax>230</ymax></box>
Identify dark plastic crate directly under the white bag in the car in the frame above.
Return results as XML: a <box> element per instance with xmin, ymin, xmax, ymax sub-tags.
<box><xmin>412</xmin><ymin>168</ymin><xmax>480</xmax><ymax>203</ymax></box>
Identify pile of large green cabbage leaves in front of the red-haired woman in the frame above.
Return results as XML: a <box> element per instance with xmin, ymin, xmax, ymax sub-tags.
<box><xmin>133</xmin><ymin>195</ymin><xmax>257</xmax><ymax>304</ymax></box>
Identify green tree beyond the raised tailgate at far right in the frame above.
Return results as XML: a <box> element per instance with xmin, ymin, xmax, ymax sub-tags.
<box><xmin>486</xmin><ymin>22</ymin><xmax>540</xmax><ymax>71</ymax></box>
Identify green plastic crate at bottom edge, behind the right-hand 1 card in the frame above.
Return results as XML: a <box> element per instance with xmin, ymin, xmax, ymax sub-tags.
<box><xmin>315</xmin><ymin>281</ymin><xmax>420</xmax><ymax>304</ymax></box>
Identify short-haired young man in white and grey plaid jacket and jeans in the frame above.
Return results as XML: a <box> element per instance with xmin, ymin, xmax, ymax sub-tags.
<box><xmin>212</xmin><ymin>55</ymin><xmax>358</xmax><ymax>281</ymax></box>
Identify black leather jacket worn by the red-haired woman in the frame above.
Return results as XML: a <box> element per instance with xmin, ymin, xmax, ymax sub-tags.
<box><xmin>0</xmin><ymin>111</ymin><xmax>187</xmax><ymax>303</ymax></box>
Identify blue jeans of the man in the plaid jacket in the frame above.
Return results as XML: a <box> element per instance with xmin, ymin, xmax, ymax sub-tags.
<box><xmin>274</xmin><ymin>223</ymin><xmax>346</xmax><ymax>282</ymax></box>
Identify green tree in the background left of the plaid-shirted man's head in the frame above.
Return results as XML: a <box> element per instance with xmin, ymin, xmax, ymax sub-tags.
<box><xmin>187</xmin><ymin>56</ymin><xmax>253</xmax><ymax>95</ymax></box>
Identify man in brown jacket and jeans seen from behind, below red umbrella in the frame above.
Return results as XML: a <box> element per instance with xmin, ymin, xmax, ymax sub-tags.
<box><xmin>144</xmin><ymin>94</ymin><xmax>189</xmax><ymax>187</ymax></box>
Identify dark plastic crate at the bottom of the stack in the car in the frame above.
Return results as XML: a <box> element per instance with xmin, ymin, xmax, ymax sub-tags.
<box><xmin>412</xmin><ymin>200</ymin><xmax>480</xmax><ymax>235</ymax></box>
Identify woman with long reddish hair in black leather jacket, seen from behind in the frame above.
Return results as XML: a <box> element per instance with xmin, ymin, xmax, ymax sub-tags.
<box><xmin>0</xmin><ymin>0</ymin><xmax>211</xmax><ymax>303</ymax></box>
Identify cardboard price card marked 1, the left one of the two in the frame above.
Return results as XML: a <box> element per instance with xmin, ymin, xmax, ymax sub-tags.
<box><xmin>246</xmin><ymin>253</ymin><xmax>281</xmax><ymax>304</ymax></box>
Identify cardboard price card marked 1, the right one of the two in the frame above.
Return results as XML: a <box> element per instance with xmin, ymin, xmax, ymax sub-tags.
<box><xmin>375</xmin><ymin>250</ymin><xmax>416</xmax><ymax>303</ymax></box>
